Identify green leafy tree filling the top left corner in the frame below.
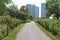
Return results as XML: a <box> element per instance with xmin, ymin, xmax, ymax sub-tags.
<box><xmin>0</xmin><ymin>0</ymin><xmax>11</xmax><ymax>15</ymax></box>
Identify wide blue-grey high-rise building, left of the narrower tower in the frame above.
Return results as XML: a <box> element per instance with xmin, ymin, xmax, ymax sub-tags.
<box><xmin>26</xmin><ymin>4</ymin><xmax>39</xmax><ymax>19</ymax></box>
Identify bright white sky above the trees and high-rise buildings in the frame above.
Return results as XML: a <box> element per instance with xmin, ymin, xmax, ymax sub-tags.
<box><xmin>12</xmin><ymin>0</ymin><xmax>46</xmax><ymax>17</ymax></box>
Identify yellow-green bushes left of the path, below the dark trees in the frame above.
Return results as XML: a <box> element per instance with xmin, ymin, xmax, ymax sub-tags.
<box><xmin>0</xmin><ymin>16</ymin><xmax>21</xmax><ymax>39</ymax></box>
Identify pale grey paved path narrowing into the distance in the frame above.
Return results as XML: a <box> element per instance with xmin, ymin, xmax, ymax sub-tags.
<box><xmin>16</xmin><ymin>22</ymin><xmax>51</xmax><ymax>40</ymax></box>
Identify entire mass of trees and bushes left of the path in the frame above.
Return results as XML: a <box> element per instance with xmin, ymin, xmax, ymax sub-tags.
<box><xmin>0</xmin><ymin>0</ymin><xmax>32</xmax><ymax>40</ymax></box>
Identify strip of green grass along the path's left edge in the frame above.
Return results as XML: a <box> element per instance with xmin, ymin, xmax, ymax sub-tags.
<box><xmin>3</xmin><ymin>23</ymin><xmax>24</xmax><ymax>40</ymax></box>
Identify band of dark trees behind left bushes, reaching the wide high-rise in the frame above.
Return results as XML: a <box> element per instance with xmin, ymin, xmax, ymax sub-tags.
<box><xmin>8</xmin><ymin>6</ymin><xmax>32</xmax><ymax>21</ymax></box>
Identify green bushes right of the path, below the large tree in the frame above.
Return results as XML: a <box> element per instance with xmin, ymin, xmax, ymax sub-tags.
<box><xmin>36</xmin><ymin>19</ymin><xmax>60</xmax><ymax>36</ymax></box>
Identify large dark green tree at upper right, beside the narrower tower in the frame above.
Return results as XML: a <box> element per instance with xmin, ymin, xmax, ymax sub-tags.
<box><xmin>46</xmin><ymin>0</ymin><xmax>60</xmax><ymax>19</ymax></box>
